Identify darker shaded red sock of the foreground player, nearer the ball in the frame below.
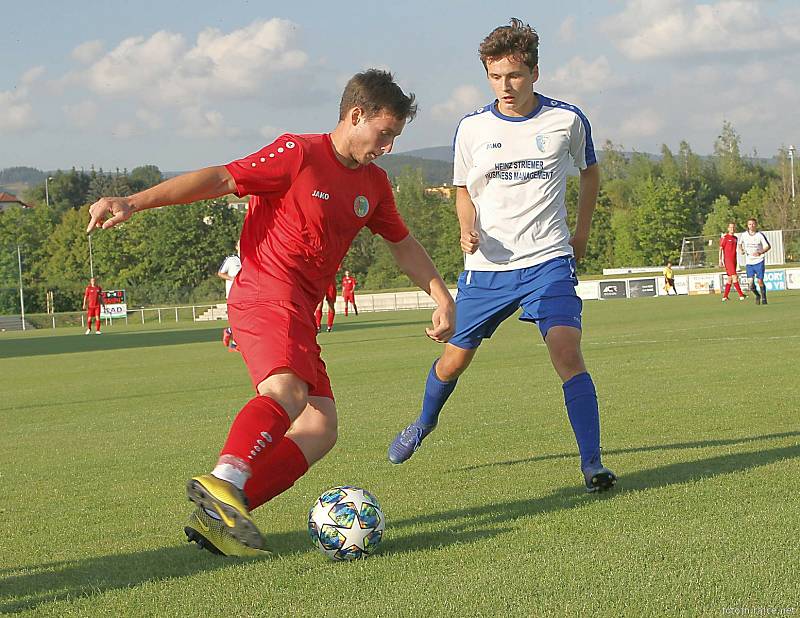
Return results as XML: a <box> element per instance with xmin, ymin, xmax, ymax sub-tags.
<box><xmin>244</xmin><ymin>436</ymin><xmax>308</xmax><ymax>511</ymax></box>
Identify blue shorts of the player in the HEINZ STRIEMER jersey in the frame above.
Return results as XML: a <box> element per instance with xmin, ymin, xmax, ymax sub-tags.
<box><xmin>449</xmin><ymin>256</ymin><xmax>583</xmax><ymax>350</ymax></box>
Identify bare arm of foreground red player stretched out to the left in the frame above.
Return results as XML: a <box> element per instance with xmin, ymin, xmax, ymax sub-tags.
<box><xmin>86</xmin><ymin>165</ymin><xmax>236</xmax><ymax>234</ymax></box>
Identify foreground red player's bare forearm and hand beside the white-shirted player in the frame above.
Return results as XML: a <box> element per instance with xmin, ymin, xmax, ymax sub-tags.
<box><xmin>387</xmin><ymin>234</ymin><xmax>456</xmax><ymax>343</ymax></box>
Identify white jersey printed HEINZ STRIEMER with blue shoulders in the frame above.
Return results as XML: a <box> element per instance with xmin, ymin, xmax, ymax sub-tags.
<box><xmin>453</xmin><ymin>94</ymin><xmax>597</xmax><ymax>271</ymax></box>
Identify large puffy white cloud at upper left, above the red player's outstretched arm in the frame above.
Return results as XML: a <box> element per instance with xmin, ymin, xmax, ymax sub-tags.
<box><xmin>86</xmin><ymin>18</ymin><xmax>308</xmax><ymax>106</ymax></box>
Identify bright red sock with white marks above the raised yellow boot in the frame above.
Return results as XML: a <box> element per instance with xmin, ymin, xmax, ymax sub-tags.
<box><xmin>220</xmin><ymin>396</ymin><xmax>292</xmax><ymax>466</ymax></box>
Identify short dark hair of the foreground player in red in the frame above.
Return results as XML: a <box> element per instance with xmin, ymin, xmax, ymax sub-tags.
<box><xmin>339</xmin><ymin>69</ymin><xmax>417</xmax><ymax>122</ymax></box>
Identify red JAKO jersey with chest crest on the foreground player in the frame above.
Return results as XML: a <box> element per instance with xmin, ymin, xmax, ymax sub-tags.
<box><xmin>225</xmin><ymin>134</ymin><xmax>408</xmax><ymax>309</ymax></box>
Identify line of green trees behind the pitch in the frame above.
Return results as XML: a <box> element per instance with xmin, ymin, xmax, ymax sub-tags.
<box><xmin>0</xmin><ymin>122</ymin><xmax>800</xmax><ymax>314</ymax></box>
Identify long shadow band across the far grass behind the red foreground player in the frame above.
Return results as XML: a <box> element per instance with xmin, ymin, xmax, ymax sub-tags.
<box><xmin>0</xmin><ymin>318</ymin><xmax>425</xmax><ymax>359</ymax></box>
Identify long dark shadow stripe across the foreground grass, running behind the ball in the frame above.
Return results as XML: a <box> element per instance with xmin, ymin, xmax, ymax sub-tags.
<box><xmin>0</xmin><ymin>434</ymin><xmax>800</xmax><ymax>613</ymax></box>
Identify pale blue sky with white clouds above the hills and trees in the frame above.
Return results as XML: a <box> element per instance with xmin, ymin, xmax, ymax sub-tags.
<box><xmin>0</xmin><ymin>0</ymin><xmax>800</xmax><ymax>171</ymax></box>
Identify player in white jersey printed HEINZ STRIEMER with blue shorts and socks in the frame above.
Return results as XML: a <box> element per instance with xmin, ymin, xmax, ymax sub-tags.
<box><xmin>389</xmin><ymin>19</ymin><xmax>616</xmax><ymax>492</ymax></box>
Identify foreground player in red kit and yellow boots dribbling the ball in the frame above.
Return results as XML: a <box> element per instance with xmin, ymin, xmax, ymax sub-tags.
<box><xmin>87</xmin><ymin>69</ymin><xmax>455</xmax><ymax>555</ymax></box>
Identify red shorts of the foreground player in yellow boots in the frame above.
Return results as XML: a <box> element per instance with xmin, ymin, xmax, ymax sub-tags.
<box><xmin>228</xmin><ymin>301</ymin><xmax>333</xmax><ymax>399</ymax></box>
